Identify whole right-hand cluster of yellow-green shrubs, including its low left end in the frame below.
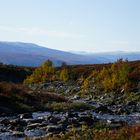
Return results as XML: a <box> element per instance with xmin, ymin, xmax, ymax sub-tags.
<box><xmin>82</xmin><ymin>59</ymin><xmax>131</xmax><ymax>92</ymax></box>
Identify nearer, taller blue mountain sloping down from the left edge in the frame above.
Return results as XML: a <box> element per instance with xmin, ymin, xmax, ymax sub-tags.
<box><xmin>0</xmin><ymin>42</ymin><xmax>99</xmax><ymax>66</ymax></box>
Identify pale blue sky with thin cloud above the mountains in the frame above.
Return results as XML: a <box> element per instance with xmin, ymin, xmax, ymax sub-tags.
<box><xmin>0</xmin><ymin>0</ymin><xmax>140</xmax><ymax>52</ymax></box>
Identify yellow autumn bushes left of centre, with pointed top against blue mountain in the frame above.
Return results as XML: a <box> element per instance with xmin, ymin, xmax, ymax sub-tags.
<box><xmin>24</xmin><ymin>60</ymin><xmax>69</xmax><ymax>84</ymax></box>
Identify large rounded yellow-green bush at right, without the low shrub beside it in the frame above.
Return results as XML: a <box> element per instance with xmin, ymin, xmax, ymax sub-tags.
<box><xmin>94</xmin><ymin>59</ymin><xmax>129</xmax><ymax>92</ymax></box>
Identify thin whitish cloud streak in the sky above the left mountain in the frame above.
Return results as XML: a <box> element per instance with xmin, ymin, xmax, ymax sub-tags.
<box><xmin>0</xmin><ymin>26</ymin><xmax>83</xmax><ymax>38</ymax></box>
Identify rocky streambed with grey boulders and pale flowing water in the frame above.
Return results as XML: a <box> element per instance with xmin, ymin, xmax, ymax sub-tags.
<box><xmin>0</xmin><ymin>82</ymin><xmax>140</xmax><ymax>140</ymax></box>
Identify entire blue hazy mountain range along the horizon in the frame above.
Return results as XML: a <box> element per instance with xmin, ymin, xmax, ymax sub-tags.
<box><xmin>0</xmin><ymin>42</ymin><xmax>140</xmax><ymax>66</ymax></box>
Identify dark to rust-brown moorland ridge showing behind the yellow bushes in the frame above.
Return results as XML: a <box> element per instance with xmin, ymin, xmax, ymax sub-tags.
<box><xmin>0</xmin><ymin>60</ymin><xmax>140</xmax><ymax>83</ymax></box>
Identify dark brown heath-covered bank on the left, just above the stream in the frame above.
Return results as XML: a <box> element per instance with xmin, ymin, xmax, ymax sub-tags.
<box><xmin>0</xmin><ymin>82</ymin><xmax>67</xmax><ymax>113</ymax></box>
